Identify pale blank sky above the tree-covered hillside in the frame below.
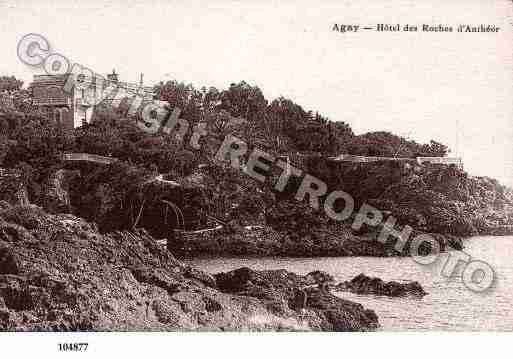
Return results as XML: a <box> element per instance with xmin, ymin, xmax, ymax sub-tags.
<box><xmin>0</xmin><ymin>0</ymin><xmax>513</xmax><ymax>186</ymax></box>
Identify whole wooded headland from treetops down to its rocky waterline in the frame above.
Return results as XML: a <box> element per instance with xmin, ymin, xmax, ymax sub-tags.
<box><xmin>0</xmin><ymin>82</ymin><xmax>513</xmax><ymax>256</ymax></box>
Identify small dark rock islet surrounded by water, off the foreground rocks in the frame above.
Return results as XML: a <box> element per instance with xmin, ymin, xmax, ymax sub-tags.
<box><xmin>335</xmin><ymin>274</ymin><xmax>427</xmax><ymax>297</ymax></box>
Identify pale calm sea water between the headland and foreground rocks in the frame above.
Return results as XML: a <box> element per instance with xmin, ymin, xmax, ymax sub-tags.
<box><xmin>186</xmin><ymin>236</ymin><xmax>513</xmax><ymax>331</ymax></box>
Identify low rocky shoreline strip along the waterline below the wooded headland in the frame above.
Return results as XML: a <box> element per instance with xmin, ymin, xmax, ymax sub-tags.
<box><xmin>168</xmin><ymin>226</ymin><xmax>463</xmax><ymax>257</ymax></box>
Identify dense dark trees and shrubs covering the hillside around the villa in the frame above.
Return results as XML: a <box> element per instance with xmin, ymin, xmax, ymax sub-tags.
<box><xmin>0</xmin><ymin>78</ymin><xmax>513</xmax><ymax>246</ymax></box>
